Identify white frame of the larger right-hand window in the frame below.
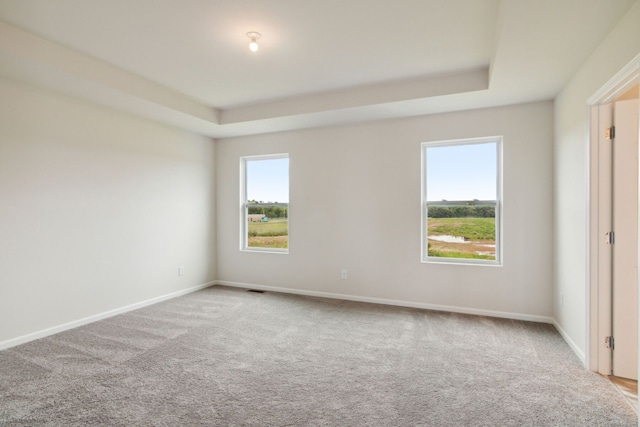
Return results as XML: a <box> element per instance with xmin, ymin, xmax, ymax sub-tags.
<box><xmin>420</xmin><ymin>136</ymin><xmax>503</xmax><ymax>266</ymax></box>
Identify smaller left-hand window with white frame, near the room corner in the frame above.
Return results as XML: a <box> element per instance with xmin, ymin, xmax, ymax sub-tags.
<box><xmin>240</xmin><ymin>154</ymin><xmax>289</xmax><ymax>253</ymax></box>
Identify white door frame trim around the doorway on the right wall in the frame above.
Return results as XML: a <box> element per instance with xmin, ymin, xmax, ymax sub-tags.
<box><xmin>585</xmin><ymin>55</ymin><xmax>640</xmax><ymax>375</ymax></box>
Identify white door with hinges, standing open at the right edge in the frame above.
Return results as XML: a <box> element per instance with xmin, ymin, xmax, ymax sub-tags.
<box><xmin>612</xmin><ymin>99</ymin><xmax>638</xmax><ymax>380</ymax></box>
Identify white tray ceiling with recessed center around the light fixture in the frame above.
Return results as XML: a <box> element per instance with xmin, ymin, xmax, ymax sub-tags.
<box><xmin>0</xmin><ymin>0</ymin><xmax>635</xmax><ymax>137</ymax></box>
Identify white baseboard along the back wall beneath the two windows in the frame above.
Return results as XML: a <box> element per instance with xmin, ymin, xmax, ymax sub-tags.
<box><xmin>213</xmin><ymin>280</ymin><xmax>553</xmax><ymax>324</ymax></box>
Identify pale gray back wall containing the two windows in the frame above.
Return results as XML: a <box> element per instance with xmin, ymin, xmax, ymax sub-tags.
<box><xmin>216</xmin><ymin>102</ymin><xmax>553</xmax><ymax>321</ymax></box>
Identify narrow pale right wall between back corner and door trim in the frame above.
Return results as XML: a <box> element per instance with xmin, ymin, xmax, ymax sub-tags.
<box><xmin>553</xmin><ymin>2</ymin><xmax>640</xmax><ymax>358</ymax></box>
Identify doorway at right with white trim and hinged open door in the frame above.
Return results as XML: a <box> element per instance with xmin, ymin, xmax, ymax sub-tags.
<box><xmin>586</xmin><ymin>57</ymin><xmax>640</xmax><ymax>412</ymax></box>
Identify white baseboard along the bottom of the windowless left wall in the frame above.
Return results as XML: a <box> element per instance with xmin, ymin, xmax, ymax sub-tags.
<box><xmin>0</xmin><ymin>282</ymin><xmax>215</xmax><ymax>350</ymax></box>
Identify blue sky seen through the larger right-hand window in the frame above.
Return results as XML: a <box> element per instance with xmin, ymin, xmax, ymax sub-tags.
<box><xmin>427</xmin><ymin>142</ymin><xmax>497</xmax><ymax>202</ymax></box>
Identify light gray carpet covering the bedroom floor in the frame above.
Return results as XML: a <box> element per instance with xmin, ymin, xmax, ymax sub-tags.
<box><xmin>0</xmin><ymin>287</ymin><xmax>637</xmax><ymax>426</ymax></box>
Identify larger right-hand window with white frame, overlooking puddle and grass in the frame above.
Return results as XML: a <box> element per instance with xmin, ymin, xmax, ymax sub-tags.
<box><xmin>422</xmin><ymin>137</ymin><xmax>502</xmax><ymax>265</ymax></box>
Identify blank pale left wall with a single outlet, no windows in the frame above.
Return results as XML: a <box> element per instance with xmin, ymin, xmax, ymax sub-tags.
<box><xmin>0</xmin><ymin>79</ymin><xmax>216</xmax><ymax>348</ymax></box>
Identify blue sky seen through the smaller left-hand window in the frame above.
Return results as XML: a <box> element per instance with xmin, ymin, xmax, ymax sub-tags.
<box><xmin>246</xmin><ymin>158</ymin><xmax>289</xmax><ymax>203</ymax></box>
